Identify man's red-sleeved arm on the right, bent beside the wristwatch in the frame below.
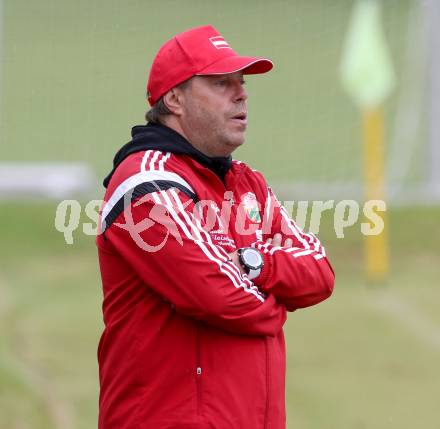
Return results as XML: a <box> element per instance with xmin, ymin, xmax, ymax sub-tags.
<box><xmin>231</xmin><ymin>188</ymin><xmax>335</xmax><ymax>311</ymax></box>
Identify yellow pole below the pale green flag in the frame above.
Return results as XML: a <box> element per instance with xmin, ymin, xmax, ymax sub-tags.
<box><xmin>363</xmin><ymin>107</ymin><xmax>389</xmax><ymax>282</ymax></box>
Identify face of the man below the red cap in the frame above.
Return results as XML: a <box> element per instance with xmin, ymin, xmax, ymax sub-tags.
<box><xmin>180</xmin><ymin>73</ymin><xmax>247</xmax><ymax>156</ymax></box>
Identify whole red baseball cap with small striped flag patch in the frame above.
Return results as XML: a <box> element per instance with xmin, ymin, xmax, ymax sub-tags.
<box><xmin>147</xmin><ymin>25</ymin><xmax>273</xmax><ymax>106</ymax></box>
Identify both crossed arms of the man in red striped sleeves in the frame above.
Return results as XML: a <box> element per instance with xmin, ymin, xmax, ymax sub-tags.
<box><xmin>106</xmin><ymin>189</ymin><xmax>333</xmax><ymax>335</ymax></box>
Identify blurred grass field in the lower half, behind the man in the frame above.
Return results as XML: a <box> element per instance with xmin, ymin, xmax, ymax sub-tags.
<box><xmin>0</xmin><ymin>204</ymin><xmax>440</xmax><ymax>429</ymax></box>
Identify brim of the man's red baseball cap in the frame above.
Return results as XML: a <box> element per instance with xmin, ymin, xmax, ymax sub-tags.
<box><xmin>196</xmin><ymin>55</ymin><xmax>273</xmax><ymax>76</ymax></box>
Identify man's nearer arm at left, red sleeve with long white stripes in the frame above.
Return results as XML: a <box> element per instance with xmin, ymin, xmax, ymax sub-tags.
<box><xmin>106</xmin><ymin>189</ymin><xmax>286</xmax><ymax>336</ymax></box>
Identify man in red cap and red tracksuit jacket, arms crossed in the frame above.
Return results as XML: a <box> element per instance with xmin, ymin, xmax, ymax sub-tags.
<box><xmin>97</xmin><ymin>26</ymin><xmax>334</xmax><ymax>429</ymax></box>
